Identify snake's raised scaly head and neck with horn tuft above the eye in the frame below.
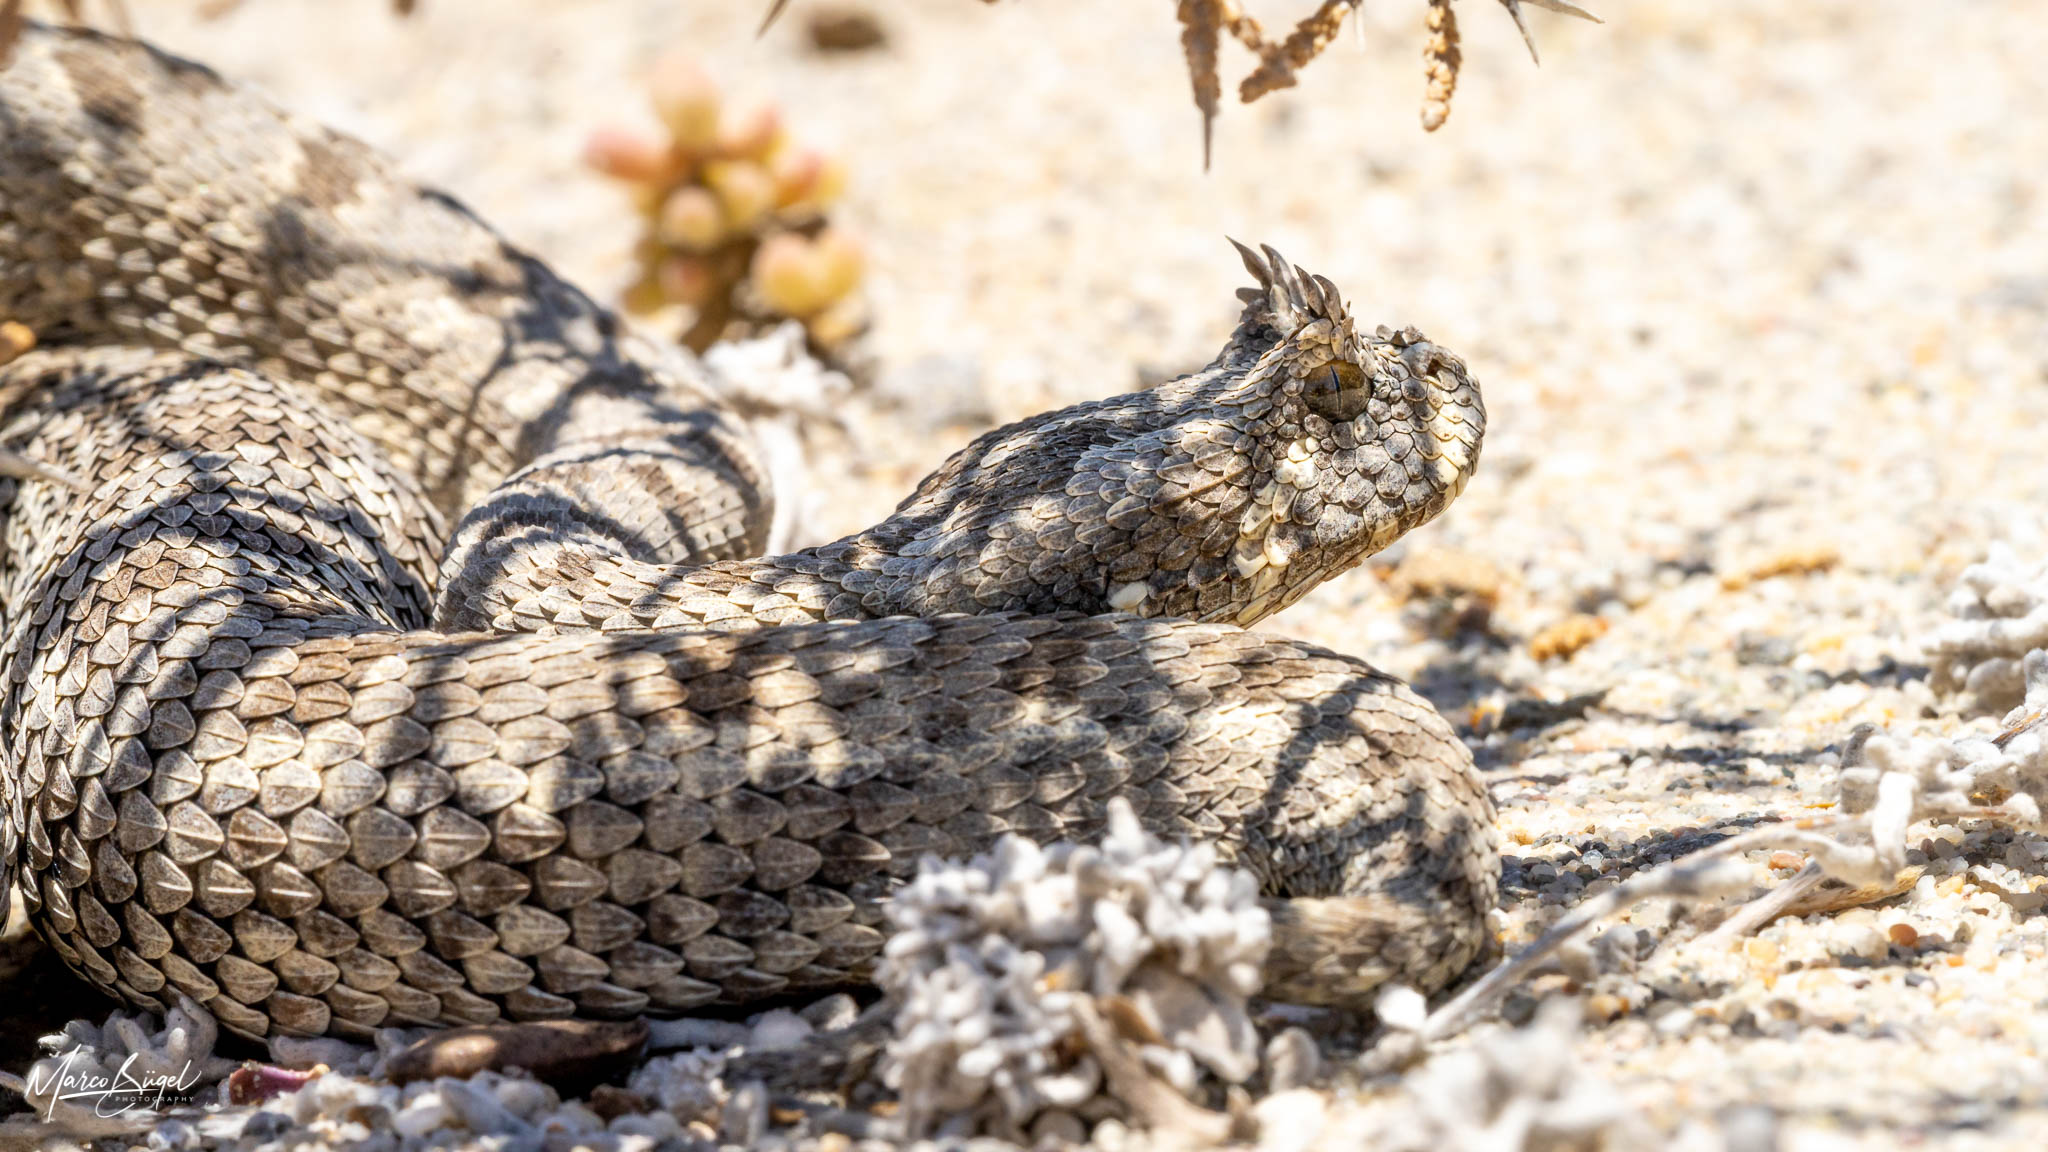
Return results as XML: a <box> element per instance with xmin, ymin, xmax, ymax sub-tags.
<box><xmin>856</xmin><ymin>237</ymin><xmax>1487</xmax><ymax>623</ymax></box>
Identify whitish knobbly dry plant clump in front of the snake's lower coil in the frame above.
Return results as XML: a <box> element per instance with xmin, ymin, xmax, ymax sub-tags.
<box><xmin>879</xmin><ymin>799</ymin><xmax>1270</xmax><ymax>1138</ymax></box>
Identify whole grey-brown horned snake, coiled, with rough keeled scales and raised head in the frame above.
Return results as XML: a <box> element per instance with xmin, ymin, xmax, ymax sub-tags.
<box><xmin>0</xmin><ymin>29</ymin><xmax>1497</xmax><ymax>1035</ymax></box>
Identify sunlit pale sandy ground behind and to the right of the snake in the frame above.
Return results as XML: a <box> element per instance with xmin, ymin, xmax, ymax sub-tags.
<box><xmin>12</xmin><ymin>0</ymin><xmax>2048</xmax><ymax>1148</ymax></box>
